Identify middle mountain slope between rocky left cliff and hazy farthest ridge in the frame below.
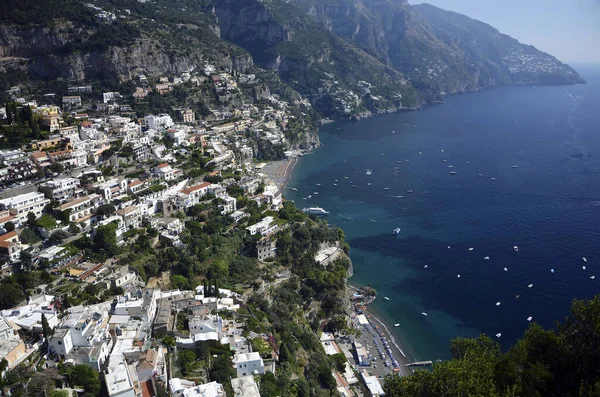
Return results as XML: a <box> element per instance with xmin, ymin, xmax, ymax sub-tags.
<box><xmin>214</xmin><ymin>0</ymin><xmax>422</xmax><ymax>116</ymax></box>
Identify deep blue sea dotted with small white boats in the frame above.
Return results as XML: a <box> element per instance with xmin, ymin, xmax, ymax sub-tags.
<box><xmin>285</xmin><ymin>67</ymin><xmax>600</xmax><ymax>360</ymax></box>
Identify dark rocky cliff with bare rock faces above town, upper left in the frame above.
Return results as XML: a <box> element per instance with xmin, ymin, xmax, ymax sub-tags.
<box><xmin>0</xmin><ymin>0</ymin><xmax>253</xmax><ymax>81</ymax></box>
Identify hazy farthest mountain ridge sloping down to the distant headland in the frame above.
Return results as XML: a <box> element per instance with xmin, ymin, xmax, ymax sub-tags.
<box><xmin>295</xmin><ymin>0</ymin><xmax>583</xmax><ymax>101</ymax></box>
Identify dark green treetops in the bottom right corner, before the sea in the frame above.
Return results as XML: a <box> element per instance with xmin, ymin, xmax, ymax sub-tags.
<box><xmin>385</xmin><ymin>296</ymin><xmax>600</xmax><ymax>397</ymax></box>
